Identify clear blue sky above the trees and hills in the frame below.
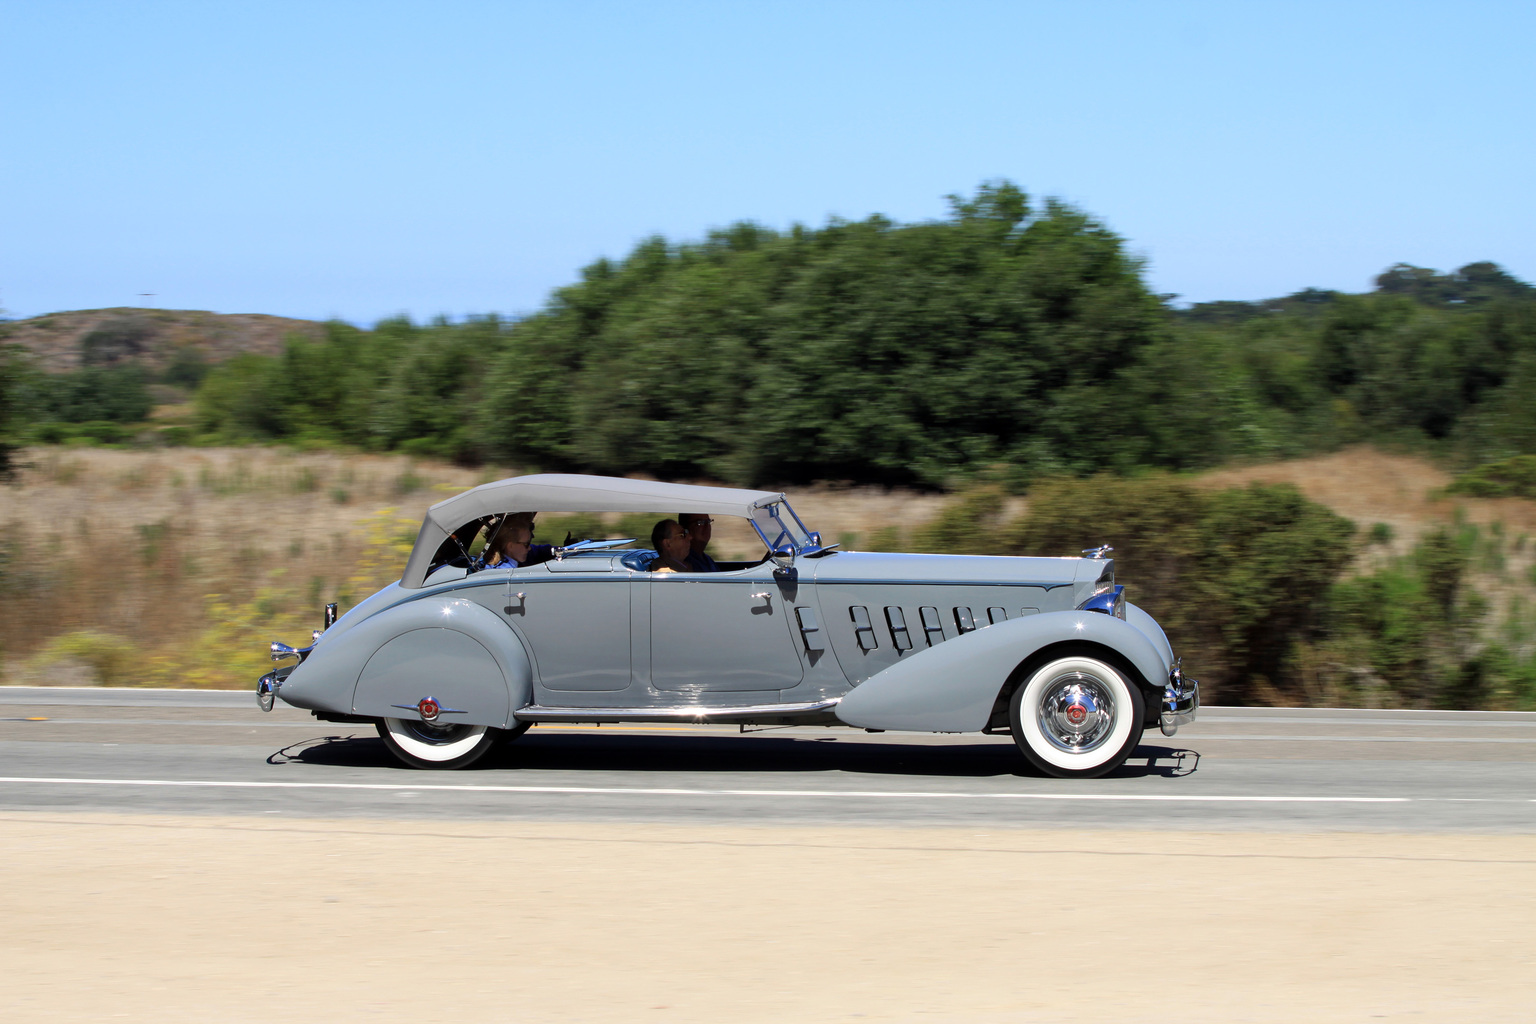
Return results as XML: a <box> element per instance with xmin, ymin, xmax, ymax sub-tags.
<box><xmin>0</xmin><ymin>0</ymin><xmax>1536</xmax><ymax>324</ymax></box>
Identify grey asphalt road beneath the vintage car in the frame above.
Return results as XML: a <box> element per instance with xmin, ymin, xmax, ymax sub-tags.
<box><xmin>0</xmin><ymin>686</ymin><xmax>1536</xmax><ymax>834</ymax></box>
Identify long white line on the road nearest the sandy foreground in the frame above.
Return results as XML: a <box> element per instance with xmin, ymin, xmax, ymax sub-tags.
<box><xmin>0</xmin><ymin>775</ymin><xmax>1415</xmax><ymax>803</ymax></box>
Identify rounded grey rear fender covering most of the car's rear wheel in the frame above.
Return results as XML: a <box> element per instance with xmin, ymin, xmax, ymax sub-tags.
<box><xmin>278</xmin><ymin>594</ymin><xmax>533</xmax><ymax>728</ymax></box>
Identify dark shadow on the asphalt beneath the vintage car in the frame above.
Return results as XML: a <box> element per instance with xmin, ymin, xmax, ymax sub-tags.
<box><xmin>267</xmin><ymin>729</ymin><xmax>1200</xmax><ymax>778</ymax></box>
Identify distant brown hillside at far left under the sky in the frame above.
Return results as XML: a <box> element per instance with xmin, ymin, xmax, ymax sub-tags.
<box><xmin>0</xmin><ymin>307</ymin><xmax>324</xmax><ymax>373</ymax></box>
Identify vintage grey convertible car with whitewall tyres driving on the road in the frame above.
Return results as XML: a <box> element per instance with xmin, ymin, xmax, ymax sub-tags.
<box><xmin>258</xmin><ymin>474</ymin><xmax>1200</xmax><ymax>777</ymax></box>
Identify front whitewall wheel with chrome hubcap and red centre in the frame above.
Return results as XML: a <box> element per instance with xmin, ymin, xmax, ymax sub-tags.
<box><xmin>1008</xmin><ymin>656</ymin><xmax>1146</xmax><ymax>778</ymax></box>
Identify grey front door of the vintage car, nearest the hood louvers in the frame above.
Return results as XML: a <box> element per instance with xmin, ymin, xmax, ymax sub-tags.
<box><xmin>641</xmin><ymin>562</ymin><xmax>805</xmax><ymax>700</ymax></box>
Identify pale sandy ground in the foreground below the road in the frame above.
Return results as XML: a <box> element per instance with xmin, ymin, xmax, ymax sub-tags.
<box><xmin>0</xmin><ymin>814</ymin><xmax>1536</xmax><ymax>1022</ymax></box>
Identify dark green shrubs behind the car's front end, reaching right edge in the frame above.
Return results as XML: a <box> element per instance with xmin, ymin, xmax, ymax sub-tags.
<box><xmin>909</xmin><ymin>476</ymin><xmax>1536</xmax><ymax>709</ymax></box>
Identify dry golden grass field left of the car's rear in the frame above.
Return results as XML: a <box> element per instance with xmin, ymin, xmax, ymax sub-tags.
<box><xmin>0</xmin><ymin>448</ymin><xmax>479</xmax><ymax>685</ymax></box>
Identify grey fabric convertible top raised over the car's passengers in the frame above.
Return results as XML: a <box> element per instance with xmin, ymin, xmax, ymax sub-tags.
<box><xmin>399</xmin><ymin>473</ymin><xmax>783</xmax><ymax>588</ymax></box>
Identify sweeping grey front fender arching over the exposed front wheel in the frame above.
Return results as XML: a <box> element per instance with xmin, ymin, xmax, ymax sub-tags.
<box><xmin>837</xmin><ymin>609</ymin><xmax>1172</xmax><ymax>732</ymax></box>
